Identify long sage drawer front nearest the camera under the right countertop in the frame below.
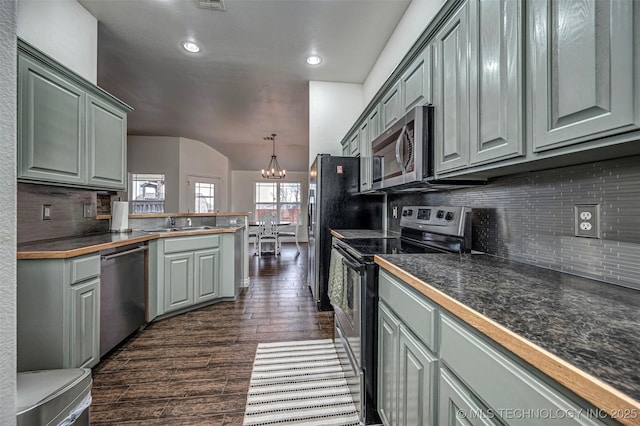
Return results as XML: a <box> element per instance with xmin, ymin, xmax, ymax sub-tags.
<box><xmin>440</xmin><ymin>314</ymin><xmax>601</xmax><ymax>425</ymax></box>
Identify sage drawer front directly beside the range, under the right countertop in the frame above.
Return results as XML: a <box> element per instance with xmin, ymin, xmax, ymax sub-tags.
<box><xmin>379</xmin><ymin>270</ymin><xmax>438</xmax><ymax>352</ymax></box>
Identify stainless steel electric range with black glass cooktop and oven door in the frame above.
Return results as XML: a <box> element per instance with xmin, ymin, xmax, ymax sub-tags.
<box><xmin>332</xmin><ymin>206</ymin><xmax>471</xmax><ymax>424</ymax></box>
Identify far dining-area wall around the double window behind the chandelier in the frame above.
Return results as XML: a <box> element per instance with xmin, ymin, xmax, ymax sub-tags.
<box><xmin>231</xmin><ymin>170</ymin><xmax>309</xmax><ymax>242</ymax></box>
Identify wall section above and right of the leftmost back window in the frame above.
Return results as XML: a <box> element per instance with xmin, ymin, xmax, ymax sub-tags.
<box><xmin>127</xmin><ymin>136</ymin><xmax>180</xmax><ymax>213</ymax></box>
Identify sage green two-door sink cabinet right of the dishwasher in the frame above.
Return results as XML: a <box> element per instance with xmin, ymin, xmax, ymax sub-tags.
<box><xmin>158</xmin><ymin>233</ymin><xmax>239</xmax><ymax>316</ymax></box>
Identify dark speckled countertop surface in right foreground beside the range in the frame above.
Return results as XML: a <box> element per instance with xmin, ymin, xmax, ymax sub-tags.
<box><xmin>378</xmin><ymin>254</ymin><xmax>640</xmax><ymax>401</ymax></box>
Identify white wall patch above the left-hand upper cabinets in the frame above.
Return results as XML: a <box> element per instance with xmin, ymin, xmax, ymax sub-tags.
<box><xmin>16</xmin><ymin>0</ymin><xmax>98</xmax><ymax>84</ymax></box>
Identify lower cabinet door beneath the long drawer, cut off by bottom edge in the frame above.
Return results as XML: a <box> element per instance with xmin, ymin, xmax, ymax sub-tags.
<box><xmin>440</xmin><ymin>368</ymin><xmax>500</xmax><ymax>426</ymax></box>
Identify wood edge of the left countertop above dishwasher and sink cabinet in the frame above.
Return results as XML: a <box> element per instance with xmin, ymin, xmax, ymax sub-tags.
<box><xmin>16</xmin><ymin>228</ymin><xmax>242</xmax><ymax>260</ymax></box>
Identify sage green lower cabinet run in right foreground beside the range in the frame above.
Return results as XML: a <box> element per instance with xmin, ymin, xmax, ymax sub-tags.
<box><xmin>378</xmin><ymin>269</ymin><xmax>615</xmax><ymax>426</ymax></box>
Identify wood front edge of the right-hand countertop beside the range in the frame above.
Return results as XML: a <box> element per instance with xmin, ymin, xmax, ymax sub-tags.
<box><xmin>374</xmin><ymin>256</ymin><xmax>640</xmax><ymax>425</ymax></box>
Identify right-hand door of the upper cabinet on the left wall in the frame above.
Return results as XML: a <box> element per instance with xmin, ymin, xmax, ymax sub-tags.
<box><xmin>87</xmin><ymin>95</ymin><xmax>127</xmax><ymax>189</ymax></box>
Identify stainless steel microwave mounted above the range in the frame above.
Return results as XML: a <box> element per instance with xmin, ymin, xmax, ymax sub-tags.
<box><xmin>371</xmin><ymin>105</ymin><xmax>434</xmax><ymax>190</ymax></box>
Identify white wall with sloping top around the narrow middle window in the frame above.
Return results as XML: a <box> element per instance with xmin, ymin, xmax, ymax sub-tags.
<box><xmin>179</xmin><ymin>138</ymin><xmax>230</xmax><ymax>212</ymax></box>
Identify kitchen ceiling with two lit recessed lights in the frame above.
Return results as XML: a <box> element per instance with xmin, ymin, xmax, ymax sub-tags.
<box><xmin>79</xmin><ymin>0</ymin><xmax>410</xmax><ymax>171</ymax></box>
